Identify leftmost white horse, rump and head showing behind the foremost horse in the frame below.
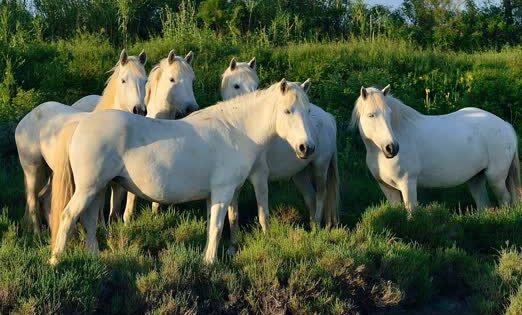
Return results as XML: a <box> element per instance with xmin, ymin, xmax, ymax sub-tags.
<box><xmin>15</xmin><ymin>50</ymin><xmax>147</xmax><ymax>233</ymax></box>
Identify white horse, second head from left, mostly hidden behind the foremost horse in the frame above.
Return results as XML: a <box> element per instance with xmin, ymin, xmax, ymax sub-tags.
<box><xmin>104</xmin><ymin>50</ymin><xmax>199</xmax><ymax>221</ymax></box>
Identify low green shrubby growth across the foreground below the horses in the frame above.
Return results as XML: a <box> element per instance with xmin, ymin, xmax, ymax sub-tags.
<box><xmin>0</xmin><ymin>204</ymin><xmax>522</xmax><ymax>314</ymax></box>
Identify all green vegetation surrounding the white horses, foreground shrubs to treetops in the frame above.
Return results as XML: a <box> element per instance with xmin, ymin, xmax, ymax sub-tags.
<box><xmin>0</xmin><ymin>0</ymin><xmax>522</xmax><ymax>314</ymax></box>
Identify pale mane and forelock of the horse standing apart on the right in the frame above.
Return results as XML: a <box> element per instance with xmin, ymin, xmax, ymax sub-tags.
<box><xmin>350</xmin><ymin>87</ymin><xmax>422</xmax><ymax>129</ymax></box>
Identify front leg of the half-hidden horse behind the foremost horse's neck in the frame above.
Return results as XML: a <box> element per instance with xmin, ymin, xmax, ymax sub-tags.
<box><xmin>249</xmin><ymin>163</ymin><xmax>270</xmax><ymax>233</ymax></box>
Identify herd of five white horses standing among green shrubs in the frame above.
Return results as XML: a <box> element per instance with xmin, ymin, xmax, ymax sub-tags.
<box><xmin>15</xmin><ymin>50</ymin><xmax>520</xmax><ymax>265</ymax></box>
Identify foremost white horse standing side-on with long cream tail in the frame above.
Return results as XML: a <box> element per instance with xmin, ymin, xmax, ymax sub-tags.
<box><xmin>50</xmin><ymin>79</ymin><xmax>315</xmax><ymax>264</ymax></box>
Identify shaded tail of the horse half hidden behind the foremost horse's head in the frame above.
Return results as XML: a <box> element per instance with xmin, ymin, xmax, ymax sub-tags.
<box><xmin>324</xmin><ymin>149</ymin><xmax>339</xmax><ymax>227</ymax></box>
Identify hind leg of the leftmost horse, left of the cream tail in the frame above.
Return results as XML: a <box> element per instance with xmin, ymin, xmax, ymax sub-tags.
<box><xmin>22</xmin><ymin>163</ymin><xmax>46</xmax><ymax>234</ymax></box>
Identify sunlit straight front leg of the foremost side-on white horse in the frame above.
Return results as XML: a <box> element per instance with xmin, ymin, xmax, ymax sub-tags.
<box><xmin>205</xmin><ymin>187</ymin><xmax>235</xmax><ymax>263</ymax></box>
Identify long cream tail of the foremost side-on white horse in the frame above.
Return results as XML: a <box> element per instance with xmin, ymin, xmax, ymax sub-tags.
<box><xmin>50</xmin><ymin>122</ymin><xmax>78</xmax><ymax>249</ymax></box>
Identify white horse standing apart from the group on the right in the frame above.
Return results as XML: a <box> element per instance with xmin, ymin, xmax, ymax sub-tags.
<box><xmin>351</xmin><ymin>85</ymin><xmax>520</xmax><ymax>216</ymax></box>
